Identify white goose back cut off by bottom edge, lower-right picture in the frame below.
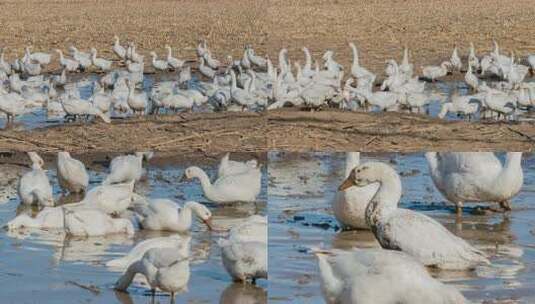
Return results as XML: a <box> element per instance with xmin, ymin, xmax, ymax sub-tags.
<box><xmin>313</xmin><ymin>249</ymin><xmax>466</xmax><ymax>304</ymax></box>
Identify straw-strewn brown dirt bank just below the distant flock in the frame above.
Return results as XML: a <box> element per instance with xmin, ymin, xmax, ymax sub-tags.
<box><xmin>0</xmin><ymin>110</ymin><xmax>535</xmax><ymax>155</ymax></box>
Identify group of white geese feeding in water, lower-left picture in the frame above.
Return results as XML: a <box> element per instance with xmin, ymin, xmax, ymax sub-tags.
<box><xmin>5</xmin><ymin>152</ymin><xmax>267</xmax><ymax>298</ymax></box>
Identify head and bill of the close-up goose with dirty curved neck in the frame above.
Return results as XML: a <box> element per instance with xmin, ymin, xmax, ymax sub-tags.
<box><xmin>338</xmin><ymin>162</ymin><xmax>399</xmax><ymax>191</ymax></box>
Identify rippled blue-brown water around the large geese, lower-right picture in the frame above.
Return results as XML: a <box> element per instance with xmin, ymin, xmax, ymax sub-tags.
<box><xmin>268</xmin><ymin>152</ymin><xmax>535</xmax><ymax>303</ymax></box>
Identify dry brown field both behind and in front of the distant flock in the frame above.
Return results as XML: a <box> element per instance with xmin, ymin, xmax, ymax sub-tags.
<box><xmin>0</xmin><ymin>0</ymin><xmax>535</xmax><ymax>152</ymax></box>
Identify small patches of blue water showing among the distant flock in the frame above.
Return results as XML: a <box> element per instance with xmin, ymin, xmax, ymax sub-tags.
<box><xmin>4</xmin><ymin>73</ymin><xmax>535</xmax><ymax>130</ymax></box>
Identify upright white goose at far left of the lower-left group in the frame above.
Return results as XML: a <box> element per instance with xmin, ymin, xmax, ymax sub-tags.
<box><xmin>18</xmin><ymin>152</ymin><xmax>54</xmax><ymax>206</ymax></box>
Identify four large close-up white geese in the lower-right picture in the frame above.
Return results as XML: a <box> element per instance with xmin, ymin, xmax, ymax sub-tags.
<box><xmin>318</xmin><ymin>152</ymin><xmax>523</xmax><ymax>304</ymax></box>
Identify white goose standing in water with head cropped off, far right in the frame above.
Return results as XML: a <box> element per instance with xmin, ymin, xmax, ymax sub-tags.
<box><xmin>425</xmin><ymin>152</ymin><xmax>524</xmax><ymax>214</ymax></box>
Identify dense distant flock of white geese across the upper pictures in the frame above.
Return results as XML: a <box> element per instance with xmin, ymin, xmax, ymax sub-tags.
<box><xmin>0</xmin><ymin>36</ymin><xmax>535</xmax><ymax>127</ymax></box>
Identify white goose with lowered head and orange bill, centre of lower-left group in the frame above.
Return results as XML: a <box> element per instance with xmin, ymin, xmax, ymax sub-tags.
<box><xmin>135</xmin><ymin>199</ymin><xmax>212</xmax><ymax>232</ymax></box>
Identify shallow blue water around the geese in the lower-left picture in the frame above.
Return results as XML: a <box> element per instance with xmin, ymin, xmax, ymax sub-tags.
<box><xmin>0</xmin><ymin>156</ymin><xmax>267</xmax><ymax>303</ymax></box>
